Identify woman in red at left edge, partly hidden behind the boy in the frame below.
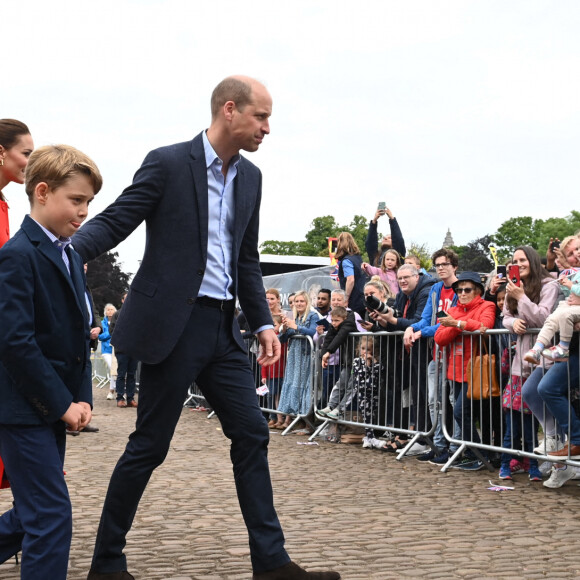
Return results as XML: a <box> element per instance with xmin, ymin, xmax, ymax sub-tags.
<box><xmin>0</xmin><ymin>119</ymin><xmax>34</xmax><ymax>487</ymax></box>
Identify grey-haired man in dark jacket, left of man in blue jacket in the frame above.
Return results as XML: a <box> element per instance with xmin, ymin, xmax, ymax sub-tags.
<box><xmin>369</xmin><ymin>264</ymin><xmax>435</xmax><ymax>440</ymax></box>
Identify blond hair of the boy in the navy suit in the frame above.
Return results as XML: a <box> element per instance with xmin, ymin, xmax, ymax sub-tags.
<box><xmin>25</xmin><ymin>145</ymin><xmax>103</xmax><ymax>203</ymax></box>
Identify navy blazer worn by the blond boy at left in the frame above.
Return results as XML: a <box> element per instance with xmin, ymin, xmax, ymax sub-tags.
<box><xmin>0</xmin><ymin>216</ymin><xmax>92</xmax><ymax>425</ymax></box>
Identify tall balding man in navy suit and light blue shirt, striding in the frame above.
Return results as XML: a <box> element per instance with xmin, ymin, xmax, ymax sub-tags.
<box><xmin>74</xmin><ymin>77</ymin><xmax>340</xmax><ymax>580</ymax></box>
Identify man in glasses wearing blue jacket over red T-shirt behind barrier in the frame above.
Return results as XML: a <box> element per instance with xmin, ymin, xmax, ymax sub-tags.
<box><xmin>403</xmin><ymin>248</ymin><xmax>461</xmax><ymax>465</ymax></box>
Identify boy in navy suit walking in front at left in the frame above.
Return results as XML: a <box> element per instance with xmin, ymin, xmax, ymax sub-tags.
<box><xmin>0</xmin><ymin>145</ymin><xmax>102</xmax><ymax>580</ymax></box>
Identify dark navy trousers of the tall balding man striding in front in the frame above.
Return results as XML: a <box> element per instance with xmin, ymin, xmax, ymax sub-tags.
<box><xmin>92</xmin><ymin>302</ymin><xmax>290</xmax><ymax>573</ymax></box>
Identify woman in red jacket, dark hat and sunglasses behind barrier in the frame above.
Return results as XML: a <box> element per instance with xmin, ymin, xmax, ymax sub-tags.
<box><xmin>435</xmin><ymin>272</ymin><xmax>495</xmax><ymax>470</ymax></box>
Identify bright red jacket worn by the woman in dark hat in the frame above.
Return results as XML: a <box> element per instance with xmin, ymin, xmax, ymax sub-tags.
<box><xmin>435</xmin><ymin>296</ymin><xmax>495</xmax><ymax>383</ymax></box>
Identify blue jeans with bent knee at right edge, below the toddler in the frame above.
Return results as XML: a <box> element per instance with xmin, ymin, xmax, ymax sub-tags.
<box><xmin>528</xmin><ymin>353</ymin><xmax>580</xmax><ymax>445</ymax></box>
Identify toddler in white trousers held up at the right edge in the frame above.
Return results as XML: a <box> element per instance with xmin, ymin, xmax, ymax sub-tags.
<box><xmin>524</xmin><ymin>238</ymin><xmax>580</xmax><ymax>365</ymax></box>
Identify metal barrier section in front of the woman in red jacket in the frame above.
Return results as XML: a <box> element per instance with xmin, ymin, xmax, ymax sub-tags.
<box><xmin>438</xmin><ymin>329</ymin><xmax>580</xmax><ymax>472</ymax></box>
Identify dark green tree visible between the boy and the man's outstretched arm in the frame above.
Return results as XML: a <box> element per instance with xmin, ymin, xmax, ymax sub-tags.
<box><xmin>87</xmin><ymin>252</ymin><xmax>132</xmax><ymax>317</ymax></box>
